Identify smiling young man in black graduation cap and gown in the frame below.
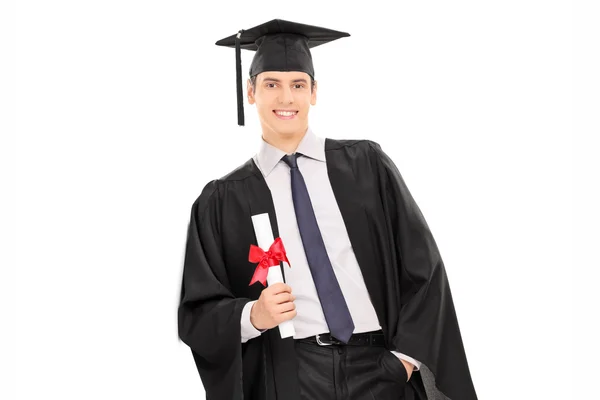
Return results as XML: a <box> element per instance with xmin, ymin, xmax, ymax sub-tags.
<box><xmin>178</xmin><ymin>20</ymin><xmax>477</xmax><ymax>400</ymax></box>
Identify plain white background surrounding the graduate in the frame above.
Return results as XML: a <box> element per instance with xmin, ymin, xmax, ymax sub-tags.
<box><xmin>0</xmin><ymin>0</ymin><xmax>598</xmax><ymax>400</ymax></box>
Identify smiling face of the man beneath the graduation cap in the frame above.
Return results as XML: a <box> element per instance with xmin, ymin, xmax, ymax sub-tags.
<box><xmin>248</xmin><ymin>71</ymin><xmax>317</xmax><ymax>139</ymax></box>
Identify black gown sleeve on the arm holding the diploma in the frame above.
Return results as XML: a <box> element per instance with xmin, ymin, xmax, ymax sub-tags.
<box><xmin>178</xmin><ymin>180</ymin><xmax>251</xmax><ymax>400</ymax></box>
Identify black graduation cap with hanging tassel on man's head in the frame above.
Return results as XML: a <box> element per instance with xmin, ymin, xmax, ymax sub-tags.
<box><xmin>215</xmin><ymin>19</ymin><xmax>350</xmax><ymax>125</ymax></box>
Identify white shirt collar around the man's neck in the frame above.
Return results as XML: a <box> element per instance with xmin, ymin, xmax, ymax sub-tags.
<box><xmin>257</xmin><ymin>127</ymin><xmax>325</xmax><ymax>176</ymax></box>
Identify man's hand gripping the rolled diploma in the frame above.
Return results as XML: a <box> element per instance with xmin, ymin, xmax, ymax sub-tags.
<box><xmin>250</xmin><ymin>283</ymin><xmax>296</xmax><ymax>331</ymax></box>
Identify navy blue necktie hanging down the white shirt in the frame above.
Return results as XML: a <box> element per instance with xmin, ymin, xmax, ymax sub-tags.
<box><xmin>282</xmin><ymin>153</ymin><xmax>354</xmax><ymax>343</ymax></box>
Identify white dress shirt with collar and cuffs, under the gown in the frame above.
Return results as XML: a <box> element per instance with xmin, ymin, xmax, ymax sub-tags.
<box><xmin>241</xmin><ymin>127</ymin><xmax>421</xmax><ymax>370</ymax></box>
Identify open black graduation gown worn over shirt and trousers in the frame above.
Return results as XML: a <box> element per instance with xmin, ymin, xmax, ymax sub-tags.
<box><xmin>178</xmin><ymin>138</ymin><xmax>477</xmax><ymax>400</ymax></box>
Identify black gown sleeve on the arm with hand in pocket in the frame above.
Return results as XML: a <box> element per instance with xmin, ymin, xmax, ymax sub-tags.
<box><xmin>369</xmin><ymin>141</ymin><xmax>477</xmax><ymax>400</ymax></box>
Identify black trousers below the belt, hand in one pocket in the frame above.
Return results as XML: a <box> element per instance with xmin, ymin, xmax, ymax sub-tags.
<box><xmin>295</xmin><ymin>340</ymin><xmax>426</xmax><ymax>400</ymax></box>
